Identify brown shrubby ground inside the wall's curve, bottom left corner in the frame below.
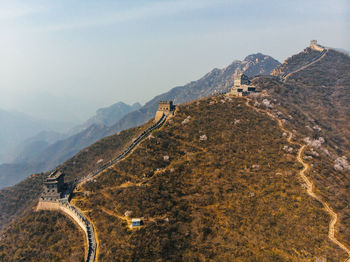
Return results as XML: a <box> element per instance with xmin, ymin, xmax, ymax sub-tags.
<box><xmin>0</xmin><ymin>211</ymin><xmax>84</xmax><ymax>262</ymax></box>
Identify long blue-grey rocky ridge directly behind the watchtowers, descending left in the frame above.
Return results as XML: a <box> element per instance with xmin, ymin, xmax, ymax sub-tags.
<box><xmin>3</xmin><ymin>53</ymin><xmax>280</xmax><ymax>189</ymax></box>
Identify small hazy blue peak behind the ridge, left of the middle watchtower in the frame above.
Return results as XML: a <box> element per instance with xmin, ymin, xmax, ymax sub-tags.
<box><xmin>69</xmin><ymin>102</ymin><xmax>141</xmax><ymax>135</ymax></box>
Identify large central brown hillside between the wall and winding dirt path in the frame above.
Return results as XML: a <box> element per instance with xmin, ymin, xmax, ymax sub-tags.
<box><xmin>74</xmin><ymin>97</ymin><xmax>344</xmax><ymax>261</ymax></box>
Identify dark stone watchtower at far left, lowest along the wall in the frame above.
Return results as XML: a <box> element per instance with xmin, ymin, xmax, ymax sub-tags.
<box><xmin>40</xmin><ymin>170</ymin><xmax>64</xmax><ymax>201</ymax></box>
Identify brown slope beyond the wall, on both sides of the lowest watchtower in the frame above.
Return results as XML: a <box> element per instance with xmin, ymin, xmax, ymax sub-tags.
<box><xmin>0</xmin><ymin>123</ymin><xmax>151</xmax><ymax>231</ymax></box>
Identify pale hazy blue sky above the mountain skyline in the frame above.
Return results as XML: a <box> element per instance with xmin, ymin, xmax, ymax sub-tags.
<box><xmin>0</xmin><ymin>0</ymin><xmax>350</xmax><ymax>121</ymax></box>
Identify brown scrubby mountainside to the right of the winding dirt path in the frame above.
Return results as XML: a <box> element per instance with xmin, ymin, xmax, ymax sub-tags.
<box><xmin>255</xmin><ymin>47</ymin><xmax>350</xmax><ymax>256</ymax></box>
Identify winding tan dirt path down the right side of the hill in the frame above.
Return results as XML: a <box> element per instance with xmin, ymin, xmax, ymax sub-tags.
<box><xmin>246</xmin><ymin>97</ymin><xmax>350</xmax><ymax>262</ymax></box>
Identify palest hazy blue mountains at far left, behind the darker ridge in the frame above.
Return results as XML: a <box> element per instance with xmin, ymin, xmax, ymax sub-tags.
<box><xmin>0</xmin><ymin>102</ymin><xmax>141</xmax><ymax>188</ymax></box>
